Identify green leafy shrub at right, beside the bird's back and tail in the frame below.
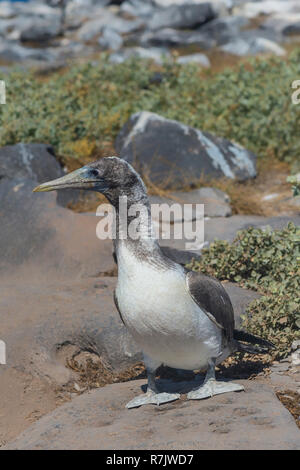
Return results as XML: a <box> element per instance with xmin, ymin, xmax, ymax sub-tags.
<box><xmin>189</xmin><ymin>223</ymin><xmax>300</xmax><ymax>357</ymax></box>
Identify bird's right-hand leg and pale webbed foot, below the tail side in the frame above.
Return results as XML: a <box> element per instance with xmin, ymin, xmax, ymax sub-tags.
<box><xmin>187</xmin><ymin>358</ymin><xmax>245</xmax><ymax>400</ymax></box>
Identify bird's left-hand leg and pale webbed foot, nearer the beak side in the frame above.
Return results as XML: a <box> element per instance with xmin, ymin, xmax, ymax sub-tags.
<box><xmin>126</xmin><ymin>368</ymin><xmax>180</xmax><ymax>408</ymax></box>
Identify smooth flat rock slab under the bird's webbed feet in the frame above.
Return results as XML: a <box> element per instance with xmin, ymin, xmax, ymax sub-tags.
<box><xmin>3</xmin><ymin>380</ymin><xmax>300</xmax><ymax>450</ymax></box>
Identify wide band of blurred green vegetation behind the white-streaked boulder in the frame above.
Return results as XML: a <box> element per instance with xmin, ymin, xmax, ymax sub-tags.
<box><xmin>0</xmin><ymin>50</ymin><xmax>300</xmax><ymax>169</ymax></box>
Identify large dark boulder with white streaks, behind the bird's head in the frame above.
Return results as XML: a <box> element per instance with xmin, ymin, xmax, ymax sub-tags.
<box><xmin>116</xmin><ymin>111</ymin><xmax>256</xmax><ymax>188</ymax></box>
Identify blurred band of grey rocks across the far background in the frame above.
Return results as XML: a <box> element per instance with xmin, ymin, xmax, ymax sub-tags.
<box><xmin>0</xmin><ymin>0</ymin><xmax>300</xmax><ymax>71</ymax></box>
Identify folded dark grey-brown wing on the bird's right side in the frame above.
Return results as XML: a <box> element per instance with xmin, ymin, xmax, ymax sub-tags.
<box><xmin>186</xmin><ymin>271</ymin><xmax>234</xmax><ymax>342</ymax></box>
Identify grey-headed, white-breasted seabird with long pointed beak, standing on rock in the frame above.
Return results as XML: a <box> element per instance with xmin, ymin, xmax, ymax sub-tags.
<box><xmin>34</xmin><ymin>157</ymin><xmax>272</xmax><ymax>408</ymax></box>
